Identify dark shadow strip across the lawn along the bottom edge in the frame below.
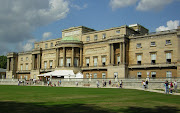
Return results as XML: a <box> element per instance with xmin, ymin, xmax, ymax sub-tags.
<box><xmin>0</xmin><ymin>102</ymin><xmax>180</xmax><ymax>113</ymax></box>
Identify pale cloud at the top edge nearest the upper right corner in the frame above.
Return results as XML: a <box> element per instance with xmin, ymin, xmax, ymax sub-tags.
<box><xmin>136</xmin><ymin>0</ymin><xmax>173</xmax><ymax>11</ymax></box>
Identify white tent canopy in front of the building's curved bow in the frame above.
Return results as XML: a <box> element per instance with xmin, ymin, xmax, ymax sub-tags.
<box><xmin>37</xmin><ymin>70</ymin><xmax>75</xmax><ymax>78</ymax></box>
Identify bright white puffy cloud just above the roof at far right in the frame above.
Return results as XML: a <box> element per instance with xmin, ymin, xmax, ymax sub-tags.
<box><xmin>156</xmin><ymin>20</ymin><xmax>179</xmax><ymax>32</ymax></box>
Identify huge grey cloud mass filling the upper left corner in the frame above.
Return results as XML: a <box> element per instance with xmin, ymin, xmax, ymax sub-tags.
<box><xmin>0</xmin><ymin>0</ymin><xmax>70</xmax><ymax>54</ymax></box>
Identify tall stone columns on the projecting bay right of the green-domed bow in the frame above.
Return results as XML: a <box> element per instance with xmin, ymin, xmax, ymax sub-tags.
<box><xmin>109</xmin><ymin>42</ymin><xmax>126</xmax><ymax>65</ymax></box>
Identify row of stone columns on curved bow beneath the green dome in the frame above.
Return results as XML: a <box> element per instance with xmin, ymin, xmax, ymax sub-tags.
<box><xmin>56</xmin><ymin>47</ymin><xmax>83</xmax><ymax>67</ymax></box>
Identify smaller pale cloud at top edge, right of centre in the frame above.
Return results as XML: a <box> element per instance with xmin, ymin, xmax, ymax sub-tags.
<box><xmin>110</xmin><ymin>0</ymin><xmax>137</xmax><ymax>10</ymax></box>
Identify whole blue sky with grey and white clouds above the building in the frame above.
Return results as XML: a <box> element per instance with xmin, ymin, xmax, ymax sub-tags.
<box><xmin>0</xmin><ymin>0</ymin><xmax>180</xmax><ymax>55</ymax></box>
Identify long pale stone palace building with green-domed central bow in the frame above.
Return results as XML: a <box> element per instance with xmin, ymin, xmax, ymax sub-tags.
<box><xmin>6</xmin><ymin>24</ymin><xmax>180</xmax><ymax>79</ymax></box>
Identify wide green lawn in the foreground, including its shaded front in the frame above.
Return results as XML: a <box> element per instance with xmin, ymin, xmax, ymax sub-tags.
<box><xmin>0</xmin><ymin>86</ymin><xmax>180</xmax><ymax>113</ymax></box>
